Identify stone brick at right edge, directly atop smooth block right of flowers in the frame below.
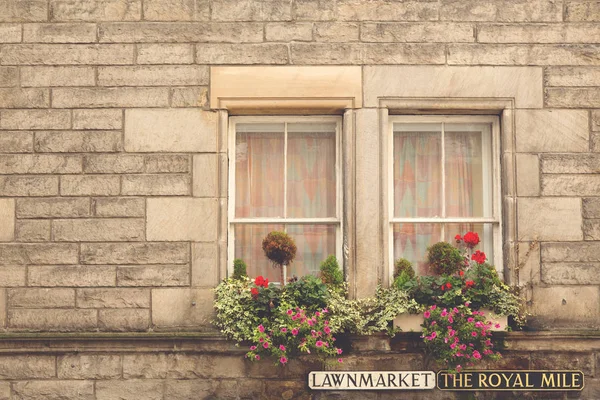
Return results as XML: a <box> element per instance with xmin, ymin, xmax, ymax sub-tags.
<box><xmin>542</xmin><ymin>263</ymin><xmax>600</xmax><ymax>285</ymax></box>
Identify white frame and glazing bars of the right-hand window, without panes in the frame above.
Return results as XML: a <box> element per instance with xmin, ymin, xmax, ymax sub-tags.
<box><xmin>387</xmin><ymin>115</ymin><xmax>503</xmax><ymax>282</ymax></box>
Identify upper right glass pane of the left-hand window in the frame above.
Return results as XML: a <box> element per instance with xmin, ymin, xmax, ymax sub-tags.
<box><xmin>287</xmin><ymin>124</ymin><xmax>336</xmax><ymax>218</ymax></box>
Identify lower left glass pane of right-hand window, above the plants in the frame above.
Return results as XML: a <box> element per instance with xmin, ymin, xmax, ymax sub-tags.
<box><xmin>393</xmin><ymin>224</ymin><xmax>442</xmax><ymax>275</ymax></box>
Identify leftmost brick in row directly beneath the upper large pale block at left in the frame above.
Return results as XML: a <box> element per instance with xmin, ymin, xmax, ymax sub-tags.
<box><xmin>0</xmin><ymin>154</ymin><xmax>82</xmax><ymax>174</ymax></box>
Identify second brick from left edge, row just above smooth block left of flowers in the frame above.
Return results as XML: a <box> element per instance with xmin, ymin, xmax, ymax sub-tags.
<box><xmin>27</xmin><ymin>265</ymin><xmax>116</xmax><ymax>287</ymax></box>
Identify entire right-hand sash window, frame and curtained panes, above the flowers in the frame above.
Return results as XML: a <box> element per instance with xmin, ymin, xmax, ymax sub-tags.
<box><xmin>388</xmin><ymin>116</ymin><xmax>502</xmax><ymax>275</ymax></box>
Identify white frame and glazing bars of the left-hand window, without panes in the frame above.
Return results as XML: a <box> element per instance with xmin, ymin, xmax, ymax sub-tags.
<box><xmin>227</xmin><ymin>115</ymin><xmax>344</xmax><ymax>283</ymax></box>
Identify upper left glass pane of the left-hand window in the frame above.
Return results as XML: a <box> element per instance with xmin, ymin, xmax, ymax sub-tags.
<box><xmin>235</xmin><ymin>124</ymin><xmax>284</xmax><ymax>218</ymax></box>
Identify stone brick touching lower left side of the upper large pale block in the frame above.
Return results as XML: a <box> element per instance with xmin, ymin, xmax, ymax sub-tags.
<box><xmin>35</xmin><ymin>131</ymin><xmax>123</xmax><ymax>153</ymax></box>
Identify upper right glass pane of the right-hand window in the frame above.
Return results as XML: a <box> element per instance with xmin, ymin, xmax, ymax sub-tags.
<box><xmin>444</xmin><ymin>124</ymin><xmax>492</xmax><ymax>217</ymax></box>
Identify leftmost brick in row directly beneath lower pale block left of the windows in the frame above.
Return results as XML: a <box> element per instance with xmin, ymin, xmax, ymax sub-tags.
<box><xmin>0</xmin><ymin>243</ymin><xmax>78</xmax><ymax>265</ymax></box>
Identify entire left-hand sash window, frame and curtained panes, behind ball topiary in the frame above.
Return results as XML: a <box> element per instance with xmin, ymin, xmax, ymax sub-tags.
<box><xmin>228</xmin><ymin>117</ymin><xmax>342</xmax><ymax>282</ymax></box>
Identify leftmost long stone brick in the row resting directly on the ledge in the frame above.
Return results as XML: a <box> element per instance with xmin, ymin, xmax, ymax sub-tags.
<box><xmin>8</xmin><ymin>308</ymin><xmax>97</xmax><ymax>332</ymax></box>
